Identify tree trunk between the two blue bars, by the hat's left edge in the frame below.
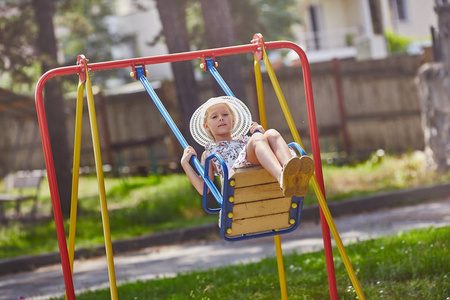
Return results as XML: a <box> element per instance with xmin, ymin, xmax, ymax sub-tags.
<box><xmin>156</xmin><ymin>0</ymin><xmax>201</xmax><ymax>151</ymax></box>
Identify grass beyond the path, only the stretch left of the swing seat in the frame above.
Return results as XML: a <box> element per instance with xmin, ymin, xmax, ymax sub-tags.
<box><xmin>0</xmin><ymin>174</ymin><xmax>217</xmax><ymax>258</ymax></box>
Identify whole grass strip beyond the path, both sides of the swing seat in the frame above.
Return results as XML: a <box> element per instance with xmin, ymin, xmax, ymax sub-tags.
<box><xmin>0</xmin><ymin>153</ymin><xmax>450</xmax><ymax>259</ymax></box>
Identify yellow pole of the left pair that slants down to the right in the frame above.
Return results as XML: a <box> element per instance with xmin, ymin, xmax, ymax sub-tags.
<box><xmin>85</xmin><ymin>62</ymin><xmax>118</xmax><ymax>300</ymax></box>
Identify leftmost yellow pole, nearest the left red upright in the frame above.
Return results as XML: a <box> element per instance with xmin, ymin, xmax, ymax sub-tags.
<box><xmin>66</xmin><ymin>80</ymin><xmax>84</xmax><ymax>299</ymax></box>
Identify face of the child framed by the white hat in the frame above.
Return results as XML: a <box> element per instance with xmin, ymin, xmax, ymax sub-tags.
<box><xmin>203</xmin><ymin>103</ymin><xmax>234</xmax><ymax>141</ymax></box>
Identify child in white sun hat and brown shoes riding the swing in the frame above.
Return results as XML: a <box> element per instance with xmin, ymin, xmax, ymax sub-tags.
<box><xmin>181</xmin><ymin>96</ymin><xmax>314</xmax><ymax>197</ymax></box>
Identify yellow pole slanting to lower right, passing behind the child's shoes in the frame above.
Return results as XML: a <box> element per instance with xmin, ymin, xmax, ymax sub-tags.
<box><xmin>263</xmin><ymin>48</ymin><xmax>365</xmax><ymax>299</ymax></box>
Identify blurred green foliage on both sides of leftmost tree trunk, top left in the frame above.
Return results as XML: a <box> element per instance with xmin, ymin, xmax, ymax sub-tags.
<box><xmin>0</xmin><ymin>0</ymin><xmax>113</xmax><ymax>93</ymax></box>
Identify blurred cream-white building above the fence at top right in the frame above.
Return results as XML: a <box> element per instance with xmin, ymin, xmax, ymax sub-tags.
<box><xmin>295</xmin><ymin>0</ymin><xmax>437</xmax><ymax>62</ymax></box>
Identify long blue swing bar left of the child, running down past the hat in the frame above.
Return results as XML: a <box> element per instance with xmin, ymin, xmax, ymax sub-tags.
<box><xmin>136</xmin><ymin>67</ymin><xmax>222</xmax><ymax>204</ymax></box>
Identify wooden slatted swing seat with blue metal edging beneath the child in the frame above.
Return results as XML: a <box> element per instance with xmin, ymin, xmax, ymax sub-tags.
<box><xmin>219</xmin><ymin>166</ymin><xmax>303</xmax><ymax>241</ymax></box>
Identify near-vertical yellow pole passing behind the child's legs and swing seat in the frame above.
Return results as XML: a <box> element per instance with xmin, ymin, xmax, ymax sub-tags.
<box><xmin>255</xmin><ymin>59</ymin><xmax>288</xmax><ymax>300</ymax></box>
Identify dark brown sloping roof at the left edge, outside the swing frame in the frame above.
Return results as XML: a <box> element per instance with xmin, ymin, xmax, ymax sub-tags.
<box><xmin>0</xmin><ymin>88</ymin><xmax>36</xmax><ymax>118</ymax></box>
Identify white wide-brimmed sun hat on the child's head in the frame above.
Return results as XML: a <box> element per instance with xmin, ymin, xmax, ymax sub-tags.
<box><xmin>189</xmin><ymin>96</ymin><xmax>252</xmax><ymax>146</ymax></box>
